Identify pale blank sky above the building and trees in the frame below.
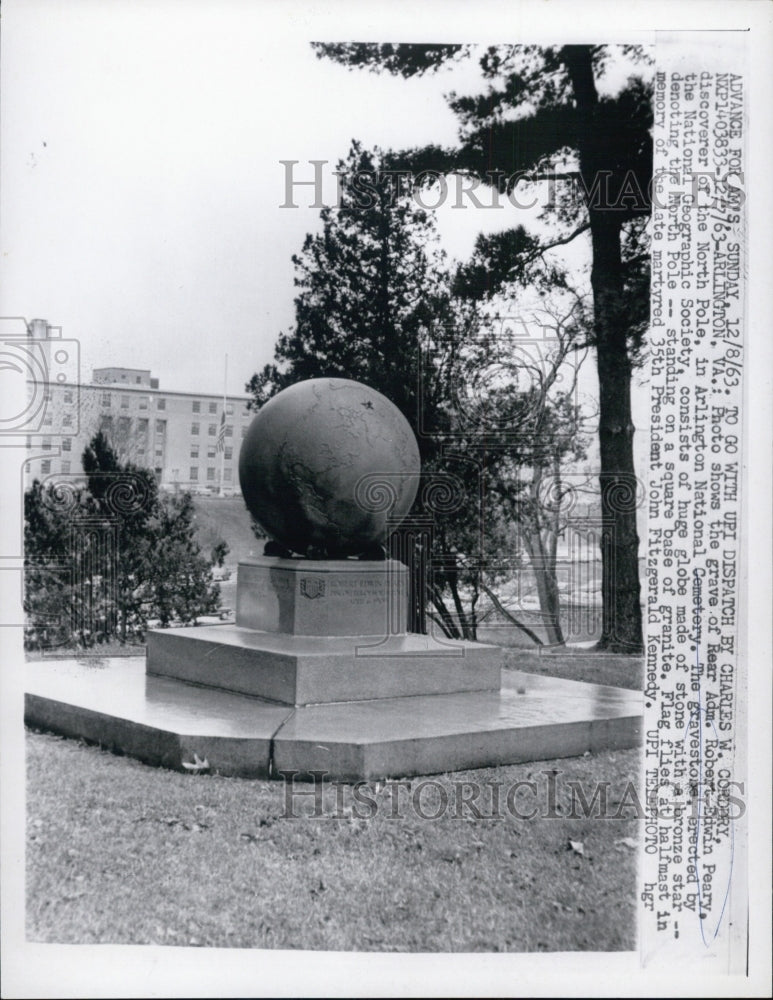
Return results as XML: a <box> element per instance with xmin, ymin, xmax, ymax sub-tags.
<box><xmin>0</xmin><ymin>0</ymin><xmax>644</xmax><ymax>418</ymax></box>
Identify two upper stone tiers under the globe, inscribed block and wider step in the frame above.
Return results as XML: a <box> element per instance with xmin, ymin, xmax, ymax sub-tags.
<box><xmin>147</xmin><ymin>558</ymin><xmax>502</xmax><ymax>706</ymax></box>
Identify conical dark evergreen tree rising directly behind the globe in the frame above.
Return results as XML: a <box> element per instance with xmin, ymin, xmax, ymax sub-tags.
<box><xmin>246</xmin><ymin>142</ymin><xmax>458</xmax><ymax>457</ymax></box>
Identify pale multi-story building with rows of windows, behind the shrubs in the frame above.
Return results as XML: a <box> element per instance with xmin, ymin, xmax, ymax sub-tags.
<box><xmin>28</xmin><ymin>368</ymin><xmax>255</xmax><ymax>496</ymax></box>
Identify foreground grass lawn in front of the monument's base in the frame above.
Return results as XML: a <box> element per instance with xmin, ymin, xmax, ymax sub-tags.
<box><xmin>27</xmin><ymin>732</ymin><xmax>639</xmax><ymax>952</ymax></box>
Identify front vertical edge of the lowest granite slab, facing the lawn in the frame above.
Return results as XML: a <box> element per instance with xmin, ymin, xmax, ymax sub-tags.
<box><xmin>25</xmin><ymin>668</ymin><xmax>642</xmax><ymax>781</ymax></box>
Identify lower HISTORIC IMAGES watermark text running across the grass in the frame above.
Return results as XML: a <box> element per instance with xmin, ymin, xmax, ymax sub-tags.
<box><xmin>278</xmin><ymin>768</ymin><xmax>746</xmax><ymax>824</ymax></box>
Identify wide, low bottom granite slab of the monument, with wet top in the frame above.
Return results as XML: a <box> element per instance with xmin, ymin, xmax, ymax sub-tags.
<box><xmin>25</xmin><ymin>658</ymin><xmax>642</xmax><ymax>781</ymax></box>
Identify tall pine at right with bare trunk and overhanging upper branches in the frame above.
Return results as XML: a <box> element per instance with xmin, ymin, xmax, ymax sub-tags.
<box><xmin>315</xmin><ymin>43</ymin><xmax>652</xmax><ymax>653</ymax></box>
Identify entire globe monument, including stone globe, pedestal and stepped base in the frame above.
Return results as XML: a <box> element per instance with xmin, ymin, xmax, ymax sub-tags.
<box><xmin>25</xmin><ymin>379</ymin><xmax>641</xmax><ymax>781</ymax></box>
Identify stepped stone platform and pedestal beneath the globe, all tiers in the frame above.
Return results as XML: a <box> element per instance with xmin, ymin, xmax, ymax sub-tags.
<box><xmin>25</xmin><ymin>558</ymin><xmax>642</xmax><ymax>780</ymax></box>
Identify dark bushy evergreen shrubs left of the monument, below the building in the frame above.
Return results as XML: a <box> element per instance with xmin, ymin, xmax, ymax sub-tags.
<box><xmin>24</xmin><ymin>432</ymin><xmax>227</xmax><ymax>648</ymax></box>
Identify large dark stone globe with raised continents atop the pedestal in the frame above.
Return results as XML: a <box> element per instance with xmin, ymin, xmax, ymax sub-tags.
<box><xmin>239</xmin><ymin>378</ymin><xmax>420</xmax><ymax>559</ymax></box>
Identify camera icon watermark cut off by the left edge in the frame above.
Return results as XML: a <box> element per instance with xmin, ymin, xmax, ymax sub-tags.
<box><xmin>0</xmin><ymin>316</ymin><xmax>80</xmax><ymax>436</ymax></box>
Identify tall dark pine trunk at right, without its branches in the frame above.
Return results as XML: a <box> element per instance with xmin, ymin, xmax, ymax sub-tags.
<box><xmin>562</xmin><ymin>45</ymin><xmax>643</xmax><ymax>653</ymax></box>
